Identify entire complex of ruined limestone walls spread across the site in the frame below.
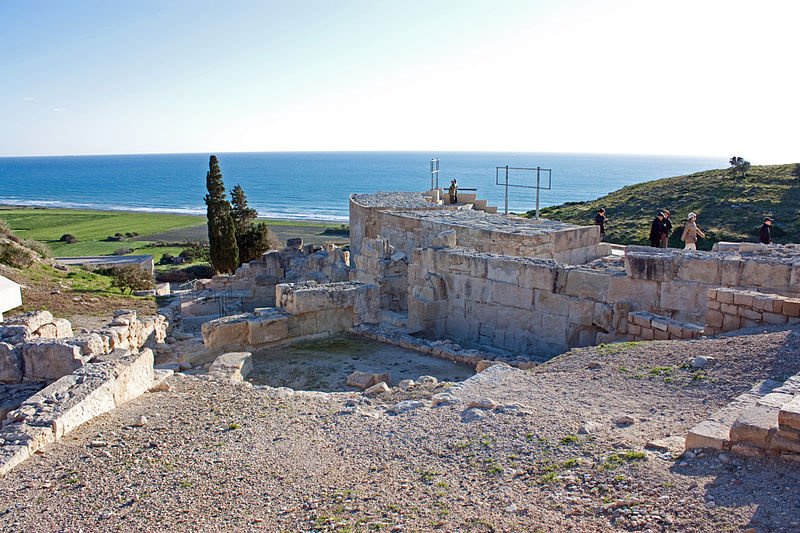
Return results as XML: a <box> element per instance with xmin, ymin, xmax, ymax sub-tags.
<box><xmin>0</xmin><ymin>188</ymin><xmax>800</xmax><ymax>471</ymax></box>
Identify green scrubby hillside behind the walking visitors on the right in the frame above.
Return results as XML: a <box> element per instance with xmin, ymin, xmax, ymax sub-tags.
<box><xmin>526</xmin><ymin>163</ymin><xmax>800</xmax><ymax>250</ymax></box>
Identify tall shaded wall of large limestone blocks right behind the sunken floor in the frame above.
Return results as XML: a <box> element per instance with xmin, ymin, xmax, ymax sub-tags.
<box><xmin>408</xmin><ymin>248</ymin><xmax>631</xmax><ymax>357</ymax></box>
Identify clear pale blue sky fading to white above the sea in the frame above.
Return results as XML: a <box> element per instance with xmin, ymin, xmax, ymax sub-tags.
<box><xmin>0</xmin><ymin>0</ymin><xmax>800</xmax><ymax>163</ymax></box>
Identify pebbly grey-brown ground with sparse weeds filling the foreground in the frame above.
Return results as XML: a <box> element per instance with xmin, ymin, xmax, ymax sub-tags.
<box><xmin>0</xmin><ymin>324</ymin><xmax>800</xmax><ymax>532</ymax></box>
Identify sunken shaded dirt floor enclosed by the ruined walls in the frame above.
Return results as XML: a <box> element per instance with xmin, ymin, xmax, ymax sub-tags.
<box><xmin>247</xmin><ymin>335</ymin><xmax>475</xmax><ymax>392</ymax></box>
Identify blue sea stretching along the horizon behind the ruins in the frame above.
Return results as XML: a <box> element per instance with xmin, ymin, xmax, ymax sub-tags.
<box><xmin>0</xmin><ymin>152</ymin><xmax>727</xmax><ymax>221</ymax></box>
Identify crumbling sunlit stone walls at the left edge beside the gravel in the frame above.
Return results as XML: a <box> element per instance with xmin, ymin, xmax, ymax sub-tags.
<box><xmin>0</xmin><ymin>309</ymin><xmax>167</xmax><ymax>475</ymax></box>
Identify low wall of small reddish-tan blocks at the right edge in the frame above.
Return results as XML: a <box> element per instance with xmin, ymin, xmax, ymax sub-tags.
<box><xmin>706</xmin><ymin>288</ymin><xmax>800</xmax><ymax>334</ymax></box>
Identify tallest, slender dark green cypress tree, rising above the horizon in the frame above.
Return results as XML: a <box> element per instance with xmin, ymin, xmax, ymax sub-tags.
<box><xmin>205</xmin><ymin>155</ymin><xmax>239</xmax><ymax>274</ymax></box>
